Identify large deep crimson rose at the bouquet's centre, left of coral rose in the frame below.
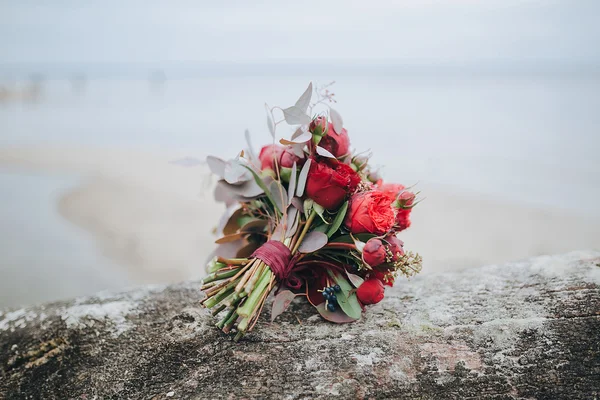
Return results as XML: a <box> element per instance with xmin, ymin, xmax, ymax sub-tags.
<box><xmin>306</xmin><ymin>158</ymin><xmax>360</xmax><ymax>210</ymax></box>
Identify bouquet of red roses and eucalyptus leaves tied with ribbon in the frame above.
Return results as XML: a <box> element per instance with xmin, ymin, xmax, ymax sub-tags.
<box><xmin>202</xmin><ymin>83</ymin><xmax>421</xmax><ymax>341</ymax></box>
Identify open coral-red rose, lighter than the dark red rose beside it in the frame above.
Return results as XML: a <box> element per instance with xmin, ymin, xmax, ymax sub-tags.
<box><xmin>344</xmin><ymin>191</ymin><xmax>395</xmax><ymax>235</ymax></box>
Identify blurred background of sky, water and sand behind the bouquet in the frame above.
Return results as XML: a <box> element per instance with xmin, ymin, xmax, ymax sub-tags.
<box><xmin>0</xmin><ymin>0</ymin><xmax>600</xmax><ymax>307</ymax></box>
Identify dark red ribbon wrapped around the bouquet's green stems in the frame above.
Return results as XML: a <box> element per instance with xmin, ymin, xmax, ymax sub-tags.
<box><xmin>252</xmin><ymin>240</ymin><xmax>302</xmax><ymax>289</ymax></box>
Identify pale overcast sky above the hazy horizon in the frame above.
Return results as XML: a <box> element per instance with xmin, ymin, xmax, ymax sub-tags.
<box><xmin>0</xmin><ymin>0</ymin><xmax>600</xmax><ymax>65</ymax></box>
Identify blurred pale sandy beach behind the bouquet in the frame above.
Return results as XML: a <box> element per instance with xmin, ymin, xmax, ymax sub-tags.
<box><xmin>0</xmin><ymin>147</ymin><xmax>600</xmax><ymax>292</ymax></box>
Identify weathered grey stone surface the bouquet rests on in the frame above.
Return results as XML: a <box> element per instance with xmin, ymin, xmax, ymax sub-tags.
<box><xmin>0</xmin><ymin>252</ymin><xmax>600</xmax><ymax>399</ymax></box>
